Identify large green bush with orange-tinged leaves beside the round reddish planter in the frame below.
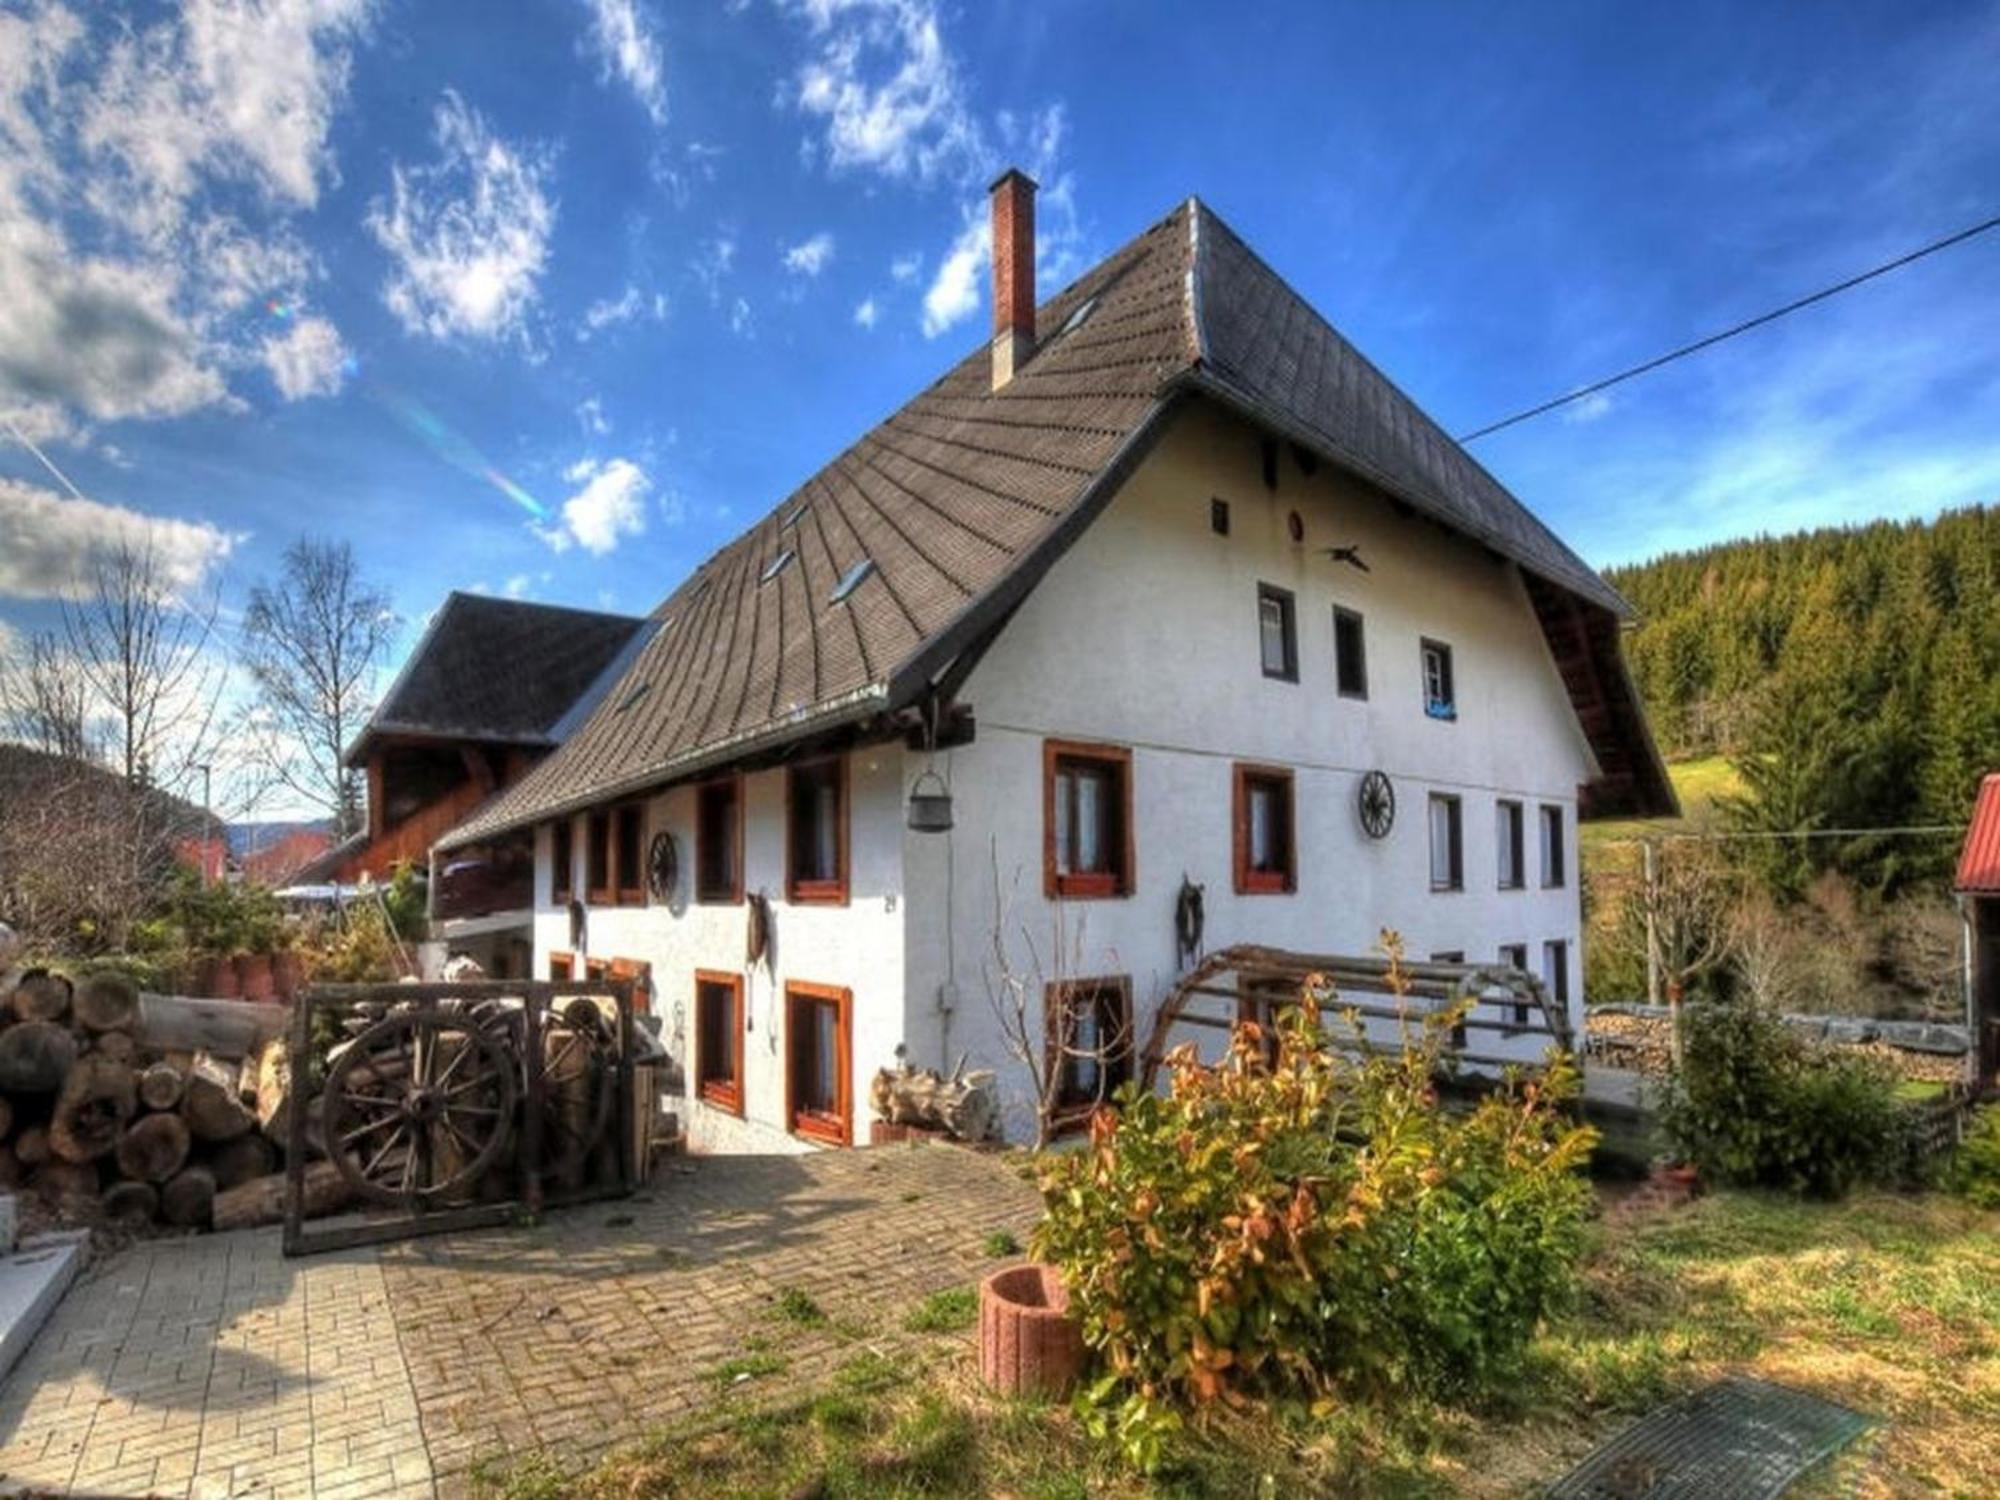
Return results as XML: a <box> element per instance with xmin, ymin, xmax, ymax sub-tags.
<box><xmin>1032</xmin><ymin>968</ymin><xmax>1592</xmax><ymax>1462</ymax></box>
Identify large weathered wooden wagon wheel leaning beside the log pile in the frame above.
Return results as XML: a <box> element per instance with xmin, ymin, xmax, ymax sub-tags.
<box><xmin>326</xmin><ymin>1010</ymin><xmax>516</xmax><ymax>1204</ymax></box>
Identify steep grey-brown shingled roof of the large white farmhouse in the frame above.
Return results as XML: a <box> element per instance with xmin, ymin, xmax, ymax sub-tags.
<box><xmin>444</xmin><ymin>200</ymin><xmax>1674</xmax><ymax>846</ymax></box>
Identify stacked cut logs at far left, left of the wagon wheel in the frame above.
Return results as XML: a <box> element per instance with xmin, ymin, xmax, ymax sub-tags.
<box><xmin>0</xmin><ymin>968</ymin><xmax>338</xmax><ymax>1228</ymax></box>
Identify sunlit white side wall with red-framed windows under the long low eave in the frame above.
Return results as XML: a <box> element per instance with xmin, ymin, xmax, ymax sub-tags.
<box><xmin>534</xmin><ymin>746</ymin><xmax>904</xmax><ymax>1152</ymax></box>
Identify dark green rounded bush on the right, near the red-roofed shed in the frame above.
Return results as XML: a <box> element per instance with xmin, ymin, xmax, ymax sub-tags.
<box><xmin>1660</xmin><ymin>1002</ymin><xmax>1908</xmax><ymax>1198</ymax></box>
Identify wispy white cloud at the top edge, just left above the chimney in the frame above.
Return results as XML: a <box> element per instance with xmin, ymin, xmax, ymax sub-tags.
<box><xmin>788</xmin><ymin>0</ymin><xmax>980</xmax><ymax>180</ymax></box>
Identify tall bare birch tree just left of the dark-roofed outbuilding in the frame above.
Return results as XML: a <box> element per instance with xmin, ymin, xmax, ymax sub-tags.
<box><xmin>242</xmin><ymin>538</ymin><xmax>396</xmax><ymax>838</ymax></box>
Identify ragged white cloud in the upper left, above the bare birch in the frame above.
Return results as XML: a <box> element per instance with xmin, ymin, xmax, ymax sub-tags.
<box><xmin>368</xmin><ymin>90</ymin><xmax>556</xmax><ymax>338</ymax></box>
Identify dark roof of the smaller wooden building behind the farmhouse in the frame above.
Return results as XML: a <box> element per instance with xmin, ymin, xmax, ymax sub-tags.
<box><xmin>346</xmin><ymin>592</ymin><xmax>644</xmax><ymax>766</ymax></box>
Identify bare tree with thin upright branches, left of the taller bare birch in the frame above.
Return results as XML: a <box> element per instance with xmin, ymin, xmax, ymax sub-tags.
<box><xmin>62</xmin><ymin>540</ymin><xmax>222</xmax><ymax>788</ymax></box>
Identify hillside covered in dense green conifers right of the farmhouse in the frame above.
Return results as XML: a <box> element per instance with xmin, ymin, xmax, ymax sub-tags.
<box><xmin>1606</xmin><ymin>506</ymin><xmax>2000</xmax><ymax>856</ymax></box>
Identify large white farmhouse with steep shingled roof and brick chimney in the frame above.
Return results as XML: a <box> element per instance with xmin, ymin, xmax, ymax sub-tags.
<box><xmin>438</xmin><ymin>172</ymin><xmax>1672</xmax><ymax>1150</ymax></box>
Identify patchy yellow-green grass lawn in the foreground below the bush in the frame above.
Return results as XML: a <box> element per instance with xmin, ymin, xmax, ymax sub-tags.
<box><xmin>476</xmin><ymin>1194</ymin><xmax>2000</xmax><ymax>1500</ymax></box>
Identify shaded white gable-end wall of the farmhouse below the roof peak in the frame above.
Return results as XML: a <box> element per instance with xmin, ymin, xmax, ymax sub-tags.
<box><xmin>906</xmin><ymin>408</ymin><xmax>1592</xmax><ymax>1134</ymax></box>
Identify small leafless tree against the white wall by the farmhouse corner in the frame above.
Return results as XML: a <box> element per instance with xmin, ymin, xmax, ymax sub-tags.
<box><xmin>986</xmin><ymin>840</ymin><xmax>1136</xmax><ymax>1148</ymax></box>
